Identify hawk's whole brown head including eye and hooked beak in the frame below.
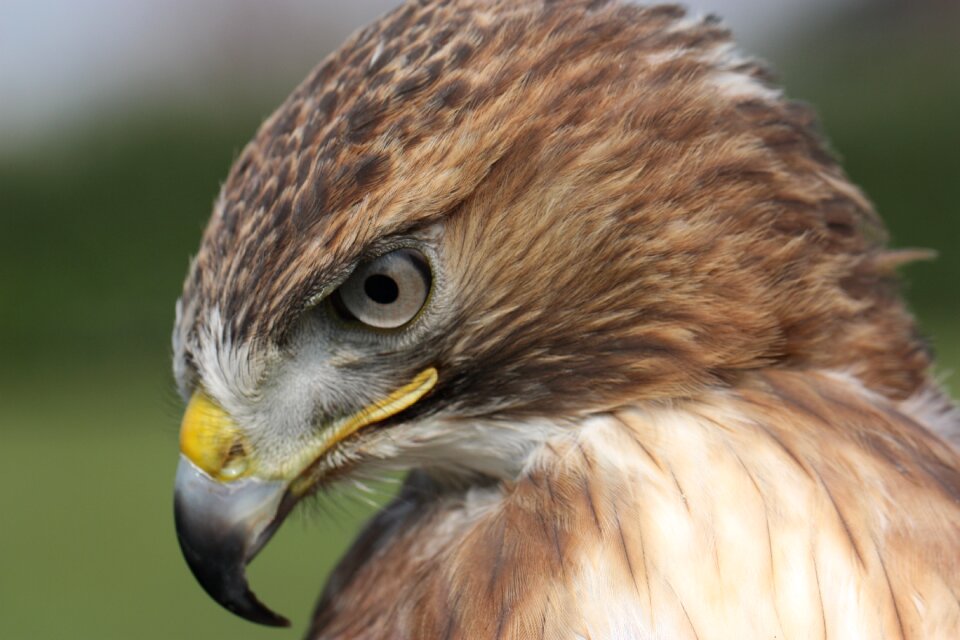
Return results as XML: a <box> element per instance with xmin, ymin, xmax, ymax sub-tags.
<box><xmin>173</xmin><ymin>0</ymin><xmax>925</xmax><ymax>624</ymax></box>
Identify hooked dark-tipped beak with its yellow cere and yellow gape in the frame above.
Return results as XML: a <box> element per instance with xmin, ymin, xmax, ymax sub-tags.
<box><xmin>173</xmin><ymin>367</ymin><xmax>437</xmax><ymax>626</ymax></box>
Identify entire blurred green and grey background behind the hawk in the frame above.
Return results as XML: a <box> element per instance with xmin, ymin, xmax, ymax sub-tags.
<box><xmin>0</xmin><ymin>0</ymin><xmax>960</xmax><ymax>640</ymax></box>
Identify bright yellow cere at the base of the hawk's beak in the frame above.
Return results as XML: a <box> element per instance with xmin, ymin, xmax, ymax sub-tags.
<box><xmin>180</xmin><ymin>391</ymin><xmax>250</xmax><ymax>482</ymax></box>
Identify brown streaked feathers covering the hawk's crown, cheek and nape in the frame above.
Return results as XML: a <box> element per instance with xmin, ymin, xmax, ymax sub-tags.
<box><xmin>178</xmin><ymin>1</ymin><xmax>929</xmax><ymax>422</ymax></box>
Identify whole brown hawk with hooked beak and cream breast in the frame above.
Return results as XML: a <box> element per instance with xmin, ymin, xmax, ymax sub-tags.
<box><xmin>173</xmin><ymin>0</ymin><xmax>960</xmax><ymax>640</ymax></box>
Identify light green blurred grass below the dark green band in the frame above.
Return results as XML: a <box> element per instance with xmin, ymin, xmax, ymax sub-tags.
<box><xmin>0</xmin><ymin>362</ymin><xmax>382</xmax><ymax>640</ymax></box>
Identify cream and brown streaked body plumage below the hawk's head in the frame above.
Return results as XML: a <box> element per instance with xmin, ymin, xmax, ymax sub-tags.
<box><xmin>311</xmin><ymin>373</ymin><xmax>960</xmax><ymax>640</ymax></box>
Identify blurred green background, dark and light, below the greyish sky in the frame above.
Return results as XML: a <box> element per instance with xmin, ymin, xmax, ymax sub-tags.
<box><xmin>0</xmin><ymin>10</ymin><xmax>960</xmax><ymax>640</ymax></box>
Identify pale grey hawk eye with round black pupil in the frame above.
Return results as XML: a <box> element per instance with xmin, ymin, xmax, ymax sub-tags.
<box><xmin>330</xmin><ymin>249</ymin><xmax>431</xmax><ymax>329</ymax></box>
